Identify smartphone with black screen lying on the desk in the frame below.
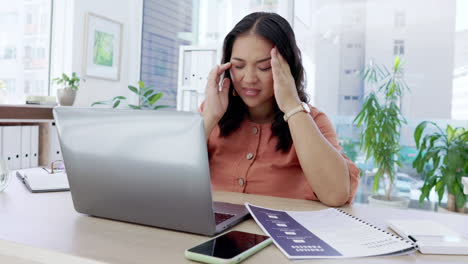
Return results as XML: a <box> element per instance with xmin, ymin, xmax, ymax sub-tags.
<box><xmin>189</xmin><ymin>231</ymin><xmax>269</xmax><ymax>259</ymax></box>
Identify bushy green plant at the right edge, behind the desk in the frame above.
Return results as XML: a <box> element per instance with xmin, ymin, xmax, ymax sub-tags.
<box><xmin>413</xmin><ymin>121</ymin><xmax>468</xmax><ymax>212</ymax></box>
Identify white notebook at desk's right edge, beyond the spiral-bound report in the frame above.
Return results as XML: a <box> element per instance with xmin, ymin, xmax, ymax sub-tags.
<box><xmin>388</xmin><ymin>220</ymin><xmax>468</xmax><ymax>255</ymax></box>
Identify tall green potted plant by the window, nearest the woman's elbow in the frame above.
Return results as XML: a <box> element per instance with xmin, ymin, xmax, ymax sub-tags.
<box><xmin>354</xmin><ymin>57</ymin><xmax>409</xmax><ymax>207</ymax></box>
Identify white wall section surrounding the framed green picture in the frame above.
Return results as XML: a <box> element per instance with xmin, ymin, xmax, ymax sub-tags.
<box><xmin>67</xmin><ymin>0</ymin><xmax>143</xmax><ymax>107</ymax></box>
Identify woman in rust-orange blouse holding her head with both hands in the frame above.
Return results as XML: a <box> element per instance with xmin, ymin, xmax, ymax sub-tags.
<box><xmin>201</xmin><ymin>12</ymin><xmax>359</xmax><ymax>206</ymax></box>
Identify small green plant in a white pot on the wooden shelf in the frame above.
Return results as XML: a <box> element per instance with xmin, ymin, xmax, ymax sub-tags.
<box><xmin>52</xmin><ymin>72</ymin><xmax>85</xmax><ymax>106</ymax></box>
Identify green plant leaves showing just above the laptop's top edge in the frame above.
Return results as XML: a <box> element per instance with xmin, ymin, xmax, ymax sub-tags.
<box><xmin>91</xmin><ymin>81</ymin><xmax>169</xmax><ymax>110</ymax></box>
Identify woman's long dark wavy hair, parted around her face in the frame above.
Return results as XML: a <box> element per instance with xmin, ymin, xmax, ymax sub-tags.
<box><xmin>218</xmin><ymin>12</ymin><xmax>309</xmax><ymax>151</ymax></box>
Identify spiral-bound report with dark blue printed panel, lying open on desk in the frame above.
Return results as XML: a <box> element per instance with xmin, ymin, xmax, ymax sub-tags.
<box><xmin>245</xmin><ymin>203</ymin><xmax>416</xmax><ymax>259</ymax></box>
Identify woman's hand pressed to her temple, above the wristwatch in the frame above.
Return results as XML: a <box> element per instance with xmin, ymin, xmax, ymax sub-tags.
<box><xmin>271</xmin><ymin>47</ymin><xmax>301</xmax><ymax>113</ymax></box>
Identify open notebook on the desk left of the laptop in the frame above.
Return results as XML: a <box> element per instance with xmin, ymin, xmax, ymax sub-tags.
<box><xmin>16</xmin><ymin>168</ymin><xmax>70</xmax><ymax>193</ymax></box>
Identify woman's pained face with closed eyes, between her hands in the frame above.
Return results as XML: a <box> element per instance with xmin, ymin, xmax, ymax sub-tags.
<box><xmin>231</xmin><ymin>34</ymin><xmax>274</xmax><ymax>108</ymax></box>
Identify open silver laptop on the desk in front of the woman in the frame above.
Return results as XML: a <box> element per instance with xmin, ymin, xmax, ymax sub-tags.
<box><xmin>53</xmin><ymin>107</ymin><xmax>248</xmax><ymax>236</ymax></box>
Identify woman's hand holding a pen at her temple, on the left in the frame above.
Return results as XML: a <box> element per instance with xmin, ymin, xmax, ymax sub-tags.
<box><xmin>203</xmin><ymin>62</ymin><xmax>231</xmax><ymax>126</ymax></box>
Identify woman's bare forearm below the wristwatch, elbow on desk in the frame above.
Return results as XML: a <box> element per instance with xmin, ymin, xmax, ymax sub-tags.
<box><xmin>288</xmin><ymin>112</ymin><xmax>350</xmax><ymax>206</ymax></box>
